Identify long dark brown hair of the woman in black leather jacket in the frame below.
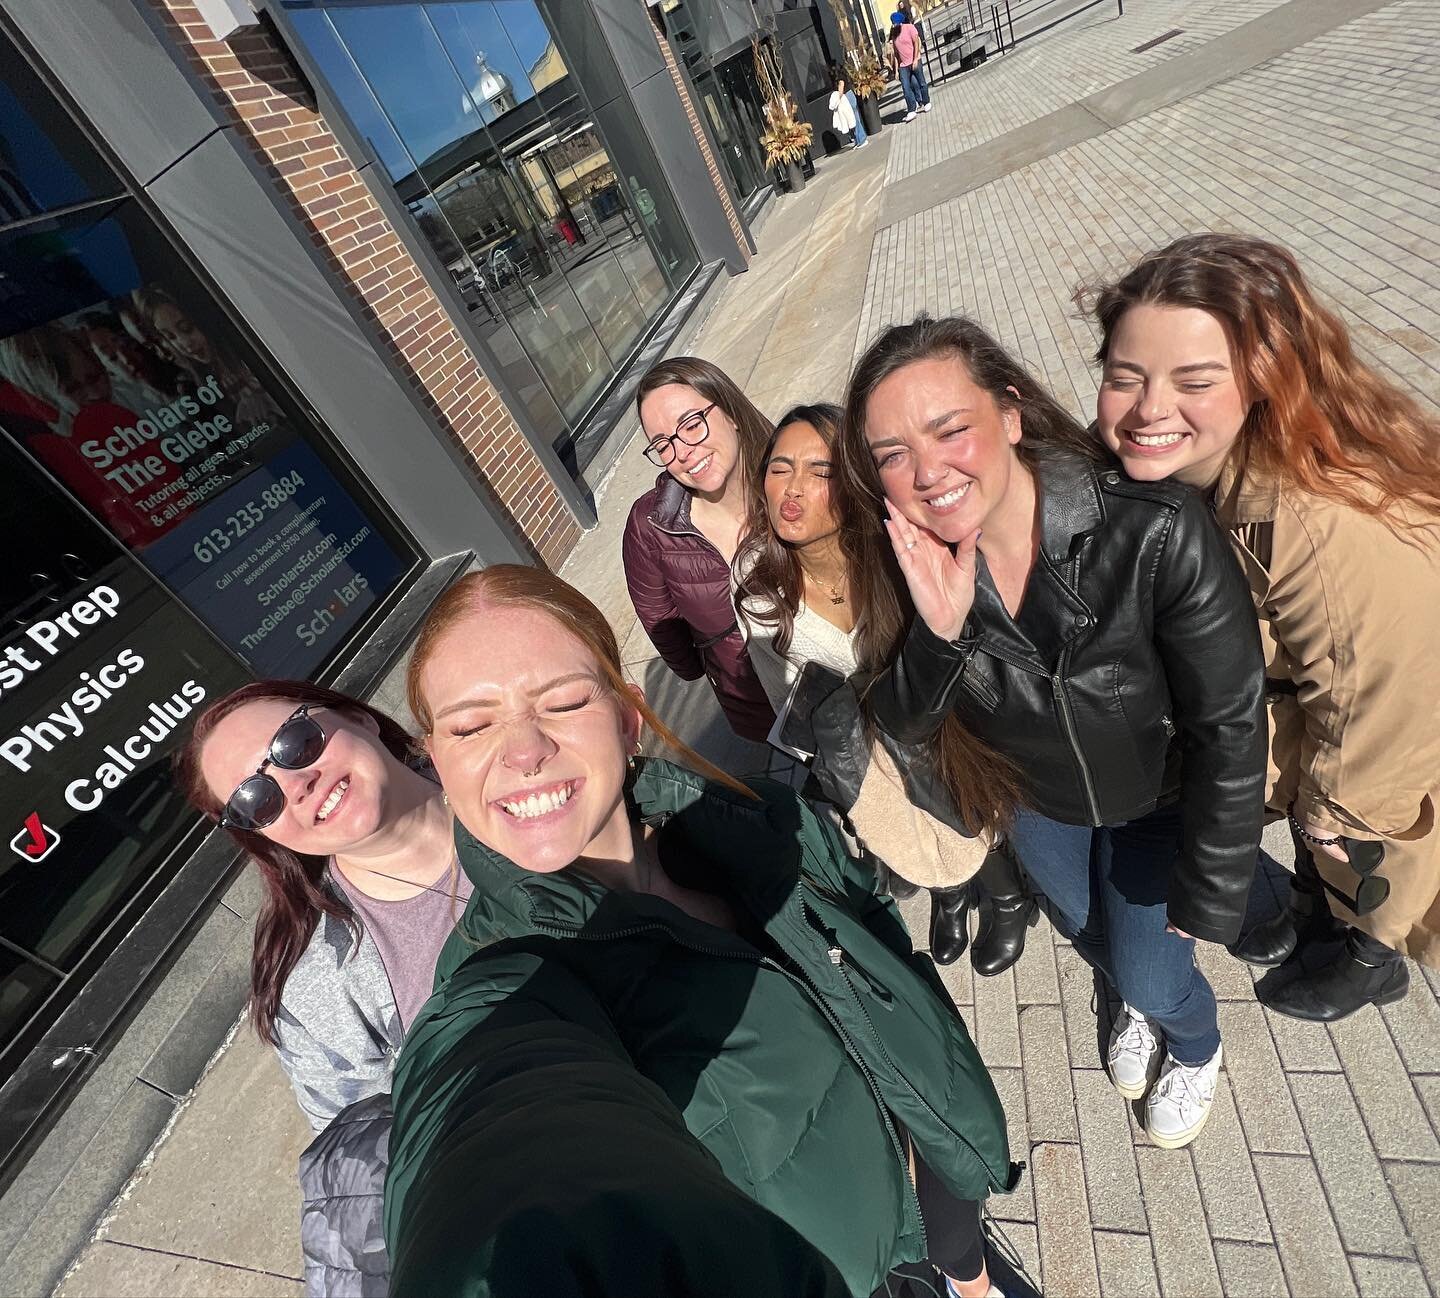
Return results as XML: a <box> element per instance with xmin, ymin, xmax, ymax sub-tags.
<box><xmin>831</xmin><ymin>315</ymin><xmax>1104</xmax><ymax>831</ymax></box>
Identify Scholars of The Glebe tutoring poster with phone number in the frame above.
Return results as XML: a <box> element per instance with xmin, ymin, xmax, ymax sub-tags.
<box><xmin>0</xmin><ymin>284</ymin><xmax>408</xmax><ymax>676</ymax></box>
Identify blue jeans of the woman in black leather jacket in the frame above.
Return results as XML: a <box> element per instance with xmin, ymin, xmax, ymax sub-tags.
<box><xmin>1011</xmin><ymin>807</ymin><xmax>1220</xmax><ymax>1063</ymax></box>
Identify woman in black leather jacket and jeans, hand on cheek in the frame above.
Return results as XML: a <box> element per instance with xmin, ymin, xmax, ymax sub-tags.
<box><xmin>838</xmin><ymin>317</ymin><xmax>1264</xmax><ymax>1147</ymax></box>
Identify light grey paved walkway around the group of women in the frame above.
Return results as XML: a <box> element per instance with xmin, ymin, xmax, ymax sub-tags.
<box><xmin>50</xmin><ymin>0</ymin><xmax>1440</xmax><ymax>1298</ymax></box>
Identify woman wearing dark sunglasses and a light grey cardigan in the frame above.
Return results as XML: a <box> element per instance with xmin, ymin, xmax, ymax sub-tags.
<box><xmin>176</xmin><ymin>680</ymin><xmax>469</xmax><ymax>1298</ymax></box>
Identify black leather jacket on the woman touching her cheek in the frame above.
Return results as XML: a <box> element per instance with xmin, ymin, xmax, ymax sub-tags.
<box><xmin>870</xmin><ymin>452</ymin><xmax>1267</xmax><ymax>944</ymax></box>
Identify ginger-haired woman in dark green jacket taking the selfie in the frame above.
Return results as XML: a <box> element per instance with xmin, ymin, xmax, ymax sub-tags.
<box><xmin>386</xmin><ymin>565</ymin><xmax>1020</xmax><ymax>1295</ymax></box>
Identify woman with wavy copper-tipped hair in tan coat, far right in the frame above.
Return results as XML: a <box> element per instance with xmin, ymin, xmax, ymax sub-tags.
<box><xmin>1093</xmin><ymin>233</ymin><xmax>1440</xmax><ymax>1021</ymax></box>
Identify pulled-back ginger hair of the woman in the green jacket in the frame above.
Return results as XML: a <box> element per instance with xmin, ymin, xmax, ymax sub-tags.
<box><xmin>405</xmin><ymin>563</ymin><xmax>755</xmax><ymax>797</ymax></box>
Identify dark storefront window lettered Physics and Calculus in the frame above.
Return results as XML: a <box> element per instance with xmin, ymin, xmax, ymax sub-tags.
<box><xmin>0</xmin><ymin>27</ymin><xmax>418</xmax><ymax>1075</ymax></box>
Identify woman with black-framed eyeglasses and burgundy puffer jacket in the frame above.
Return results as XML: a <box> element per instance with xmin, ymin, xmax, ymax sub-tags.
<box><xmin>624</xmin><ymin>356</ymin><xmax>775</xmax><ymax>740</ymax></box>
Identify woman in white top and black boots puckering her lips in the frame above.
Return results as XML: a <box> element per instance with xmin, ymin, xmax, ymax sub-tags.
<box><xmin>734</xmin><ymin>405</ymin><xmax>1037</xmax><ymax>977</ymax></box>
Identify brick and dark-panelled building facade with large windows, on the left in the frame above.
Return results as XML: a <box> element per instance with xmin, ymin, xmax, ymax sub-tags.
<box><xmin>0</xmin><ymin>0</ymin><xmax>768</xmax><ymax>1273</ymax></box>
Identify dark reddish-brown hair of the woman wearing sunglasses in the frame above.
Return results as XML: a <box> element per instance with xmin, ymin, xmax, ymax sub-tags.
<box><xmin>174</xmin><ymin>680</ymin><xmax>419</xmax><ymax>1046</ymax></box>
